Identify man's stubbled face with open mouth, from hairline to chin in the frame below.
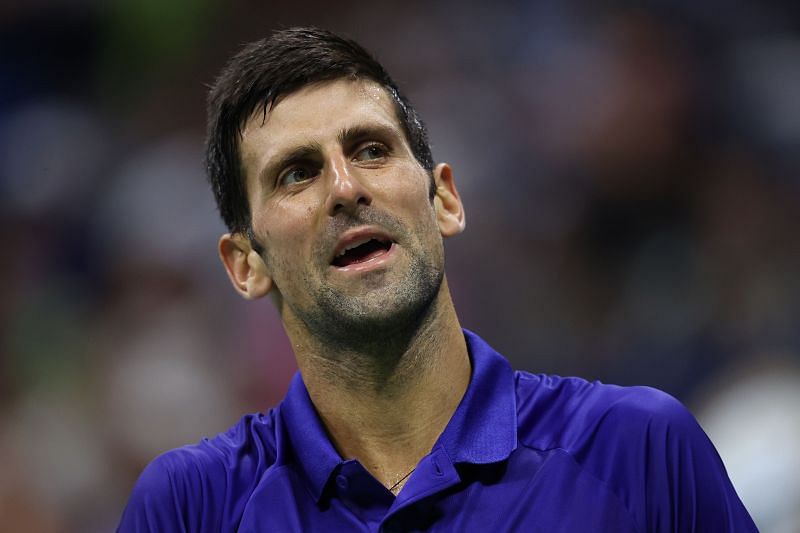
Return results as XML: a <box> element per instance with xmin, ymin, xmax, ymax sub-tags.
<box><xmin>234</xmin><ymin>79</ymin><xmax>454</xmax><ymax>339</ymax></box>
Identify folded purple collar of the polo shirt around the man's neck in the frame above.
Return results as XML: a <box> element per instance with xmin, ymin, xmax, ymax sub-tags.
<box><xmin>278</xmin><ymin>330</ymin><xmax>517</xmax><ymax>502</ymax></box>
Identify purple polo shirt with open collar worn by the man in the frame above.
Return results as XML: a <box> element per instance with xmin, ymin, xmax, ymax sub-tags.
<box><xmin>118</xmin><ymin>331</ymin><xmax>757</xmax><ymax>533</ymax></box>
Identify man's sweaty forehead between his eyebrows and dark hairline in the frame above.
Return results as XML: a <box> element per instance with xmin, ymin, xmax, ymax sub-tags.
<box><xmin>236</xmin><ymin>78</ymin><xmax>402</xmax><ymax>168</ymax></box>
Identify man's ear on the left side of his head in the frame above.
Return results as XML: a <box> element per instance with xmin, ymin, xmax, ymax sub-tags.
<box><xmin>218</xmin><ymin>233</ymin><xmax>272</xmax><ymax>300</ymax></box>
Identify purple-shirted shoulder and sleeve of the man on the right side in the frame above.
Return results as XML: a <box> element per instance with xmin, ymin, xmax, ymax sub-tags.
<box><xmin>516</xmin><ymin>372</ymin><xmax>755</xmax><ymax>532</ymax></box>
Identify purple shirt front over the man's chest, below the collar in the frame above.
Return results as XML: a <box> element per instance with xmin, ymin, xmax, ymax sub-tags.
<box><xmin>234</xmin><ymin>449</ymin><xmax>637</xmax><ymax>533</ymax></box>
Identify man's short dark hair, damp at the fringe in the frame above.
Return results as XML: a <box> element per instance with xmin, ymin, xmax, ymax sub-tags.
<box><xmin>206</xmin><ymin>28</ymin><xmax>433</xmax><ymax>235</ymax></box>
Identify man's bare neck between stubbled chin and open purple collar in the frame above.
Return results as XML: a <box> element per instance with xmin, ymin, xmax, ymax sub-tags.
<box><xmin>287</xmin><ymin>281</ymin><xmax>470</xmax><ymax>493</ymax></box>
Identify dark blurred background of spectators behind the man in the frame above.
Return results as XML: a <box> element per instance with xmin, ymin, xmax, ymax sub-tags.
<box><xmin>0</xmin><ymin>0</ymin><xmax>800</xmax><ymax>533</ymax></box>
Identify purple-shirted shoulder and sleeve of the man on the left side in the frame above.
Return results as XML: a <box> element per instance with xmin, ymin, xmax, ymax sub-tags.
<box><xmin>119</xmin><ymin>410</ymin><xmax>276</xmax><ymax>532</ymax></box>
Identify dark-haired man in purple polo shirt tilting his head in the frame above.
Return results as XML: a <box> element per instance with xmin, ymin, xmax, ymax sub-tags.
<box><xmin>119</xmin><ymin>29</ymin><xmax>755</xmax><ymax>533</ymax></box>
